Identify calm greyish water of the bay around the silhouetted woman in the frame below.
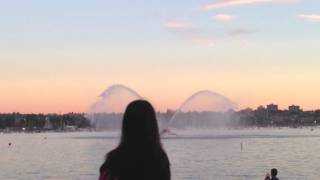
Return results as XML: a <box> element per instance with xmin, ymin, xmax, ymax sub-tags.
<box><xmin>0</xmin><ymin>129</ymin><xmax>320</xmax><ymax>180</ymax></box>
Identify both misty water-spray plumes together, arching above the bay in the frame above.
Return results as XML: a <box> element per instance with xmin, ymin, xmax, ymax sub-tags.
<box><xmin>87</xmin><ymin>84</ymin><xmax>237</xmax><ymax>132</ymax></box>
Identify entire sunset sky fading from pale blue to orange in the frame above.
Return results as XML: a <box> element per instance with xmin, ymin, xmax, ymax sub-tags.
<box><xmin>0</xmin><ymin>0</ymin><xmax>320</xmax><ymax>113</ymax></box>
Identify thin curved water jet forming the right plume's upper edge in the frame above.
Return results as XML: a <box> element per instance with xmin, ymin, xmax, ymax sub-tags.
<box><xmin>167</xmin><ymin>90</ymin><xmax>237</xmax><ymax>128</ymax></box>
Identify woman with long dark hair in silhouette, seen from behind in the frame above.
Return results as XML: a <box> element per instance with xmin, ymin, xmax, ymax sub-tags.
<box><xmin>100</xmin><ymin>100</ymin><xmax>170</xmax><ymax>180</ymax></box>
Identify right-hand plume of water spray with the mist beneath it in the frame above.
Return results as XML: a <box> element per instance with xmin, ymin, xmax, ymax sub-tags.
<box><xmin>167</xmin><ymin>90</ymin><xmax>237</xmax><ymax>130</ymax></box>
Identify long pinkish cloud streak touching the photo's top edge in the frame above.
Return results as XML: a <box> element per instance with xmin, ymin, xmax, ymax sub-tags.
<box><xmin>201</xmin><ymin>0</ymin><xmax>293</xmax><ymax>10</ymax></box>
